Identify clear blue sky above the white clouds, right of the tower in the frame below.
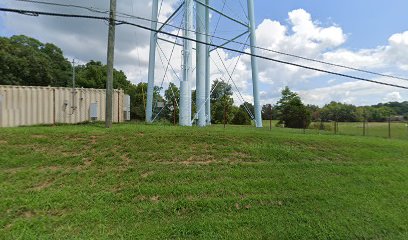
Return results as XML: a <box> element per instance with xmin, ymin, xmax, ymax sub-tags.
<box><xmin>255</xmin><ymin>0</ymin><xmax>408</xmax><ymax>49</ymax></box>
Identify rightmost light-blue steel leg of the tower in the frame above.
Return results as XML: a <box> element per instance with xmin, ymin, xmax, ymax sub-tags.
<box><xmin>247</xmin><ymin>0</ymin><xmax>262</xmax><ymax>128</ymax></box>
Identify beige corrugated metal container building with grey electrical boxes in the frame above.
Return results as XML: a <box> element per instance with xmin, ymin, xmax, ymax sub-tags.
<box><xmin>0</xmin><ymin>85</ymin><xmax>130</xmax><ymax>127</ymax></box>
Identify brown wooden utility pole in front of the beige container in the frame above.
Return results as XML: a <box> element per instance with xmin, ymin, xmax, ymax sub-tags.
<box><xmin>105</xmin><ymin>0</ymin><xmax>116</xmax><ymax>128</ymax></box>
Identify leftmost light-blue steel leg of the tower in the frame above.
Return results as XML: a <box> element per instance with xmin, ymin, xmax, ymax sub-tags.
<box><xmin>146</xmin><ymin>0</ymin><xmax>159</xmax><ymax>123</ymax></box>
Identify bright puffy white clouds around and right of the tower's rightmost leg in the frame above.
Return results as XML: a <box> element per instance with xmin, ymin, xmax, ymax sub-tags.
<box><xmin>218</xmin><ymin>9</ymin><xmax>408</xmax><ymax>105</ymax></box>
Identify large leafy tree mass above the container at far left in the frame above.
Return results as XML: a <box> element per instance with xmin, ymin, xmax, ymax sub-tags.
<box><xmin>0</xmin><ymin>35</ymin><xmax>72</xmax><ymax>87</ymax></box>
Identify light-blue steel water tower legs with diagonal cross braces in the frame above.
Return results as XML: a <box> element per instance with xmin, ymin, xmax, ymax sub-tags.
<box><xmin>146</xmin><ymin>0</ymin><xmax>262</xmax><ymax>127</ymax></box>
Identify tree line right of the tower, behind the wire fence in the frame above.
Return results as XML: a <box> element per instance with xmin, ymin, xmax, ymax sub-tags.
<box><xmin>262</xmin><ymin>87</ymin><xmax>408</xmax><ymax>128</ymax></box>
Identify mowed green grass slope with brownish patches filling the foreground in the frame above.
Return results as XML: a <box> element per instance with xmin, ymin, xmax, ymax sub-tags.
<box><xmin>0</xmin><ymin>124</ymin><xmax>408</xmax><ymax>239</ymax></box>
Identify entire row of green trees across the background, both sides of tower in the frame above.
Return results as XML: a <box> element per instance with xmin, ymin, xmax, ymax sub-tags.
<box><xmin>0</xmin><ymin>35</ymin><xmax>408</xmax><ymax>128</ymax></box>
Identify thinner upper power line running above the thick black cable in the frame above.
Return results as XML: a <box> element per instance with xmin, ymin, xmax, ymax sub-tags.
<box><xmin>9</xmin><ymin>0</ymin><xmax>408</xmax><ymax>81</ymax></box>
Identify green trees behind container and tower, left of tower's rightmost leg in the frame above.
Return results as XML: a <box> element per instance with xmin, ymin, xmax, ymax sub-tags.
<box><xmin>0</xmin><ymin>35</ymin><xmax>253</xmax><ymax>124</ymax></box>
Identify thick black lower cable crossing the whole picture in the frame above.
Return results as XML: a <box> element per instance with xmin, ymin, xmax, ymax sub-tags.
<box><xmin>0</xmin><ymin>8</ymin><xmax>408</xmax><ymax>89</ymax></box>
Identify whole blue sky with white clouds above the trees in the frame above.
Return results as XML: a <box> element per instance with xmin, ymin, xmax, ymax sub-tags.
<box><xmin>0</xmin><ymin>0</ymin><xmax>408</xmax><ymax>106</ymax></box>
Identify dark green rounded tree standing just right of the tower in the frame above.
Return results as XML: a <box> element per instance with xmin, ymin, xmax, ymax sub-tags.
<box><xmin>275</xmin><ymin>87</ymin><xmax>311</xmax><ymax>128</ymax></box>
